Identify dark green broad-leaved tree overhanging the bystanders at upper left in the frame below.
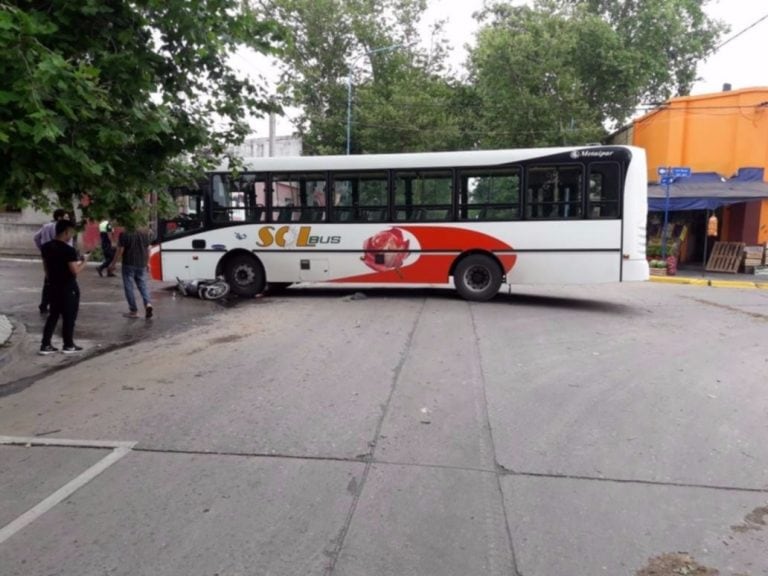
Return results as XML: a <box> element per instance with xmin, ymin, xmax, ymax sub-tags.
<box><xmin>0</xmin><ymin>0</ymin><xmax>279</xmax><ymax>217</ymax></box>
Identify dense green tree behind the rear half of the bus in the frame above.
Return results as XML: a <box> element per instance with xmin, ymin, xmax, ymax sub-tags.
<box><xmin>469</xmin><ymin>0</ymin><xmax>723</xmax><ymax>148</ymax></box>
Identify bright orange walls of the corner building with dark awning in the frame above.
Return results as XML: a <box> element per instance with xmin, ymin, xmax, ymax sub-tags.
<box><xmin>612</xmin><ymin>88</ymin><xmax>768</xmax><ymax>245</ymax></box>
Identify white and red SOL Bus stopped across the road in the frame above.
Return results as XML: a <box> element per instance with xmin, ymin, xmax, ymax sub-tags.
<box><xmin>151</xmin><ymin>146</ymin><xmax>648</xmax><ymax>300</ymax></box>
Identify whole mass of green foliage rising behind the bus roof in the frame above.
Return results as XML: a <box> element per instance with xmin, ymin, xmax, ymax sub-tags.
<box><xmin>261</xmin><ymin>0</ymin><xmax>724</xmax><ymax>154</ymax></box>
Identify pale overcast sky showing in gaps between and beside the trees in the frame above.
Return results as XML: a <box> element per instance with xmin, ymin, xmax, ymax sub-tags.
<box><xmin>243</xmin><ymin>0</ymin><xmax>768</xmax><ymax>136</ymax></box>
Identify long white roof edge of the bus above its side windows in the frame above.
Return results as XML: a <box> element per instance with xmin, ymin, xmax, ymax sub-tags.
<box><xmin>214</xmin><ymin>146</ymin><xmax>633</xmax><ymax>172</ymax></box>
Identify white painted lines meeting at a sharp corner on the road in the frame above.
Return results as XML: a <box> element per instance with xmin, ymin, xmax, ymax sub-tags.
<box><xmin>0</xmin><ymin>436</ymin><xmax>136</xmax><ymax>544</ymax></box>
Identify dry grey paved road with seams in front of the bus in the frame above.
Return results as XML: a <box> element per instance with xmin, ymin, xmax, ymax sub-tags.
<box><xmin>0</xmin><ymin>264</ymin><xmax>768</xmax><ymax>576</ymax></box>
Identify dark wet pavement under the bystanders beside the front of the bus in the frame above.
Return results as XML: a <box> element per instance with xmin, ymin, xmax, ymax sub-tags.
<box><xmin>0</xmin><ymin>259</ymin><xmax>222</xmax><ymax>395</ymax></box>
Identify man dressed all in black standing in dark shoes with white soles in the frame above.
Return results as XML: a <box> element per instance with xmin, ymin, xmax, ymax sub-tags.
<box><xmin>40</xmin><ymin>220</ymin><xmax>85</xmax><ymax>355</ymax></box>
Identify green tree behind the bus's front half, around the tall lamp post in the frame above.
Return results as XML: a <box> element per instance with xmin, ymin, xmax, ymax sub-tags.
<box><xmin>261</xmin><ymin>0</ymin><xmax>461</xmax><ymax>154</ymax></box>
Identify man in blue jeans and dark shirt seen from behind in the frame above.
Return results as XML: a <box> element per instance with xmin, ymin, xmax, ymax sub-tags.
<box><xmin>109</xmin><ymin>225</ymin><xmax>154</xmax><ymax>319</ymax></box>
